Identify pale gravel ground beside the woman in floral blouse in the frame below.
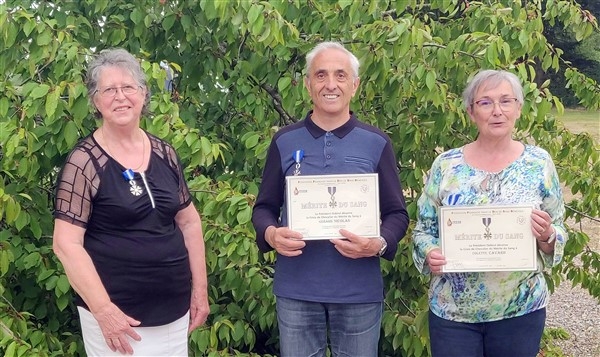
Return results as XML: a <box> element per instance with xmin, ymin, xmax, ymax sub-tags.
<box><xmin>546</xmin><ymin>282</ymin><xmax>600</xmax><ymax>357</ymax></box>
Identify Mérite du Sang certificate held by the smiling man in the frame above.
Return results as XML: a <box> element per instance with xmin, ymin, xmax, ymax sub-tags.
<box><xmin>286</xmin><ymin>173</ymin><xmax>379</xmax><ymax>239</ymax></box>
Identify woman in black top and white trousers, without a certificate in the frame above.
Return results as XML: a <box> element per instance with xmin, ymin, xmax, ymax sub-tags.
<box><xmin>53</xmin><ymin>49</ymin><xmax>209</xmax><ymax>356</ymax></box>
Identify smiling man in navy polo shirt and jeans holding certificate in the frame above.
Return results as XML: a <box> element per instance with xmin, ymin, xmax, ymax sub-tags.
<box><xmin>252</xmin><ymin>42</ymin><xmax>409</xmax><ymax>357</ymax></box>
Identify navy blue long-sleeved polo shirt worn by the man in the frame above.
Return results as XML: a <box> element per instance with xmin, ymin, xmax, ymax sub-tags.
<box><xmin>252</xmin><ymin>112</ymin><xmax>409</xmax><ymax>303</ymax></box>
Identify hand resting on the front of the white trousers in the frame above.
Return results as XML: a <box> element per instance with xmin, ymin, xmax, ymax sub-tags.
<box><xmin>92</xmin><ymin>302</ymin><xmax>142</xmax><ymax>355</ymax></box>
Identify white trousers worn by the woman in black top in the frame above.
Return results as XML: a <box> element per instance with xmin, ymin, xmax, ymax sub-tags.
<box><xmin>77</xmin><ymin>307</ymin><xmax>190</xmax><ymax>357</ymax></box>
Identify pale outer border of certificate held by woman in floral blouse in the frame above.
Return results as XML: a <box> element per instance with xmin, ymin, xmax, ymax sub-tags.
<box><xmin>438</xmin><ymin>205</ymin><xmax>538</xmax><ymax>273</ymax></box>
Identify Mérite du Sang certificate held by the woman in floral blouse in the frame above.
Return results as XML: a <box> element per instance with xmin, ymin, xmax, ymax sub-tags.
<box><xmin>439</xmin><ymin>205</ymin><xmax>537</xmax><ymax>273</ymax></box>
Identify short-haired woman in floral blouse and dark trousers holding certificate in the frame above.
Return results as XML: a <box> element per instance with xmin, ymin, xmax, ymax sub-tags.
<box><xmin>413</xmin><ymin>70</ymin><xmax>567</xmax><ymax>357</ymax></box>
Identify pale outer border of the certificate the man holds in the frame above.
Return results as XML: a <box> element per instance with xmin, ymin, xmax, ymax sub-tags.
<box><xmin>285</xmin><ymin>172</ymin><xmax>381</xmax><ymax>240</ymax></box>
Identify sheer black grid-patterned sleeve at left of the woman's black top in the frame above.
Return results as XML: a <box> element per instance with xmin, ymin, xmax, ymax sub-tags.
<box><xmin>54</xmin><ymin>137</ymin><xmax>106</xmax><ymax>228</ymax></box>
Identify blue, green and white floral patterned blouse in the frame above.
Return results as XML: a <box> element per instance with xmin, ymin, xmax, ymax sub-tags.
<box><xmin>413</xmin><ymin>145</ymin><xmax>567</xmax><ymax>322</ymax></box>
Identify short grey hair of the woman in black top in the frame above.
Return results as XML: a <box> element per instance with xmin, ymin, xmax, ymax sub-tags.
<box><xmin>85</xmin><ymin>48</ymin><xmax>150</xmax><ymax>118</ymax></box>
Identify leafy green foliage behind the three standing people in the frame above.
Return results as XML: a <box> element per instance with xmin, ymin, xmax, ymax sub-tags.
<box><xmin>0</xmin><ymin>0</ymin><xmax>600</xmax><ymax>357</ymax></box>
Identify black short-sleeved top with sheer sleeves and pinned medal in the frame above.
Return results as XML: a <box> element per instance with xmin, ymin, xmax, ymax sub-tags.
<box><xmin>54</xmin><ymin>134</ymin><xmax>191</xmax><ymax>326</ymax></box>
